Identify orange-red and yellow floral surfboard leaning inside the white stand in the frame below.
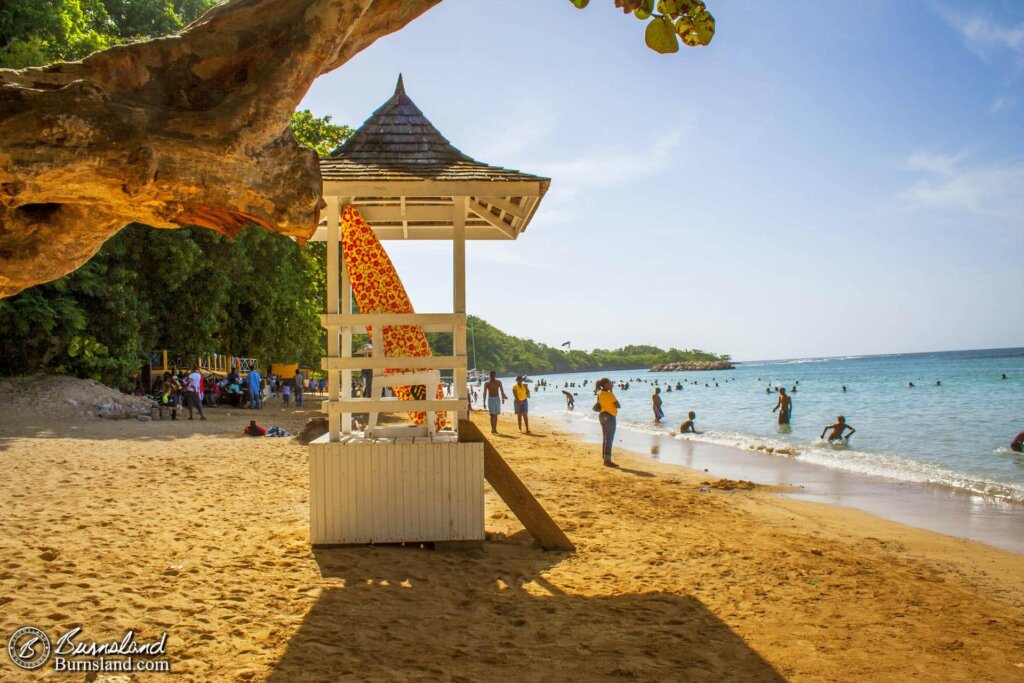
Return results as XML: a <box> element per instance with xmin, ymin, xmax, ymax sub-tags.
<box><xmin>341</xmin><ymin>206</ymin><xmax>445</xmax><ymax>430</ymax></box>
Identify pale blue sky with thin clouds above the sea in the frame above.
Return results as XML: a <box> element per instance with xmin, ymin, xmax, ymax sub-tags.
<box><xmin>302</xmin><ymin>0</ymin><xmax>1024</xmax><ymax>359</ymax></box>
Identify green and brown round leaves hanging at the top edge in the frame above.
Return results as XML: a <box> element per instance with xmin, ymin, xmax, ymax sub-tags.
<box><xmin>569</xmin><ymin>0</ymin><xmax>715</xmax><ymax>54</ymax></box>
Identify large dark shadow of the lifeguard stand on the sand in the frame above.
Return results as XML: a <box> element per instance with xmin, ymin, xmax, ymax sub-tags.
<box><xmin>269</xmin><ymin>543</ymin><xmax>783</xmax><ymax>682</ymax></box>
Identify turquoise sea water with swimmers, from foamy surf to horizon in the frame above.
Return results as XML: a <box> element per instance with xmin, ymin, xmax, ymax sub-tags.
<box><xmin>491</xmin><ymin>348</ymin><xmax>1024</xmax><ymax>503</ymax></box>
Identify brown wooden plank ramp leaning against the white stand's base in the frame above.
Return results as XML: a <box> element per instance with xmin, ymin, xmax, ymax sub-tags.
<box><xmin>459</xmin><ymin>420</ymin><xmax>575</xmax><ymax>551</ymax></box>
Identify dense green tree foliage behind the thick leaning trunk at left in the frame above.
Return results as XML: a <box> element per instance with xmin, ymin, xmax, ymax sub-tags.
<box><xmin>0</xmin><ymin>0</ymin><xmax>344</xmax><ymax>382</ymax></box>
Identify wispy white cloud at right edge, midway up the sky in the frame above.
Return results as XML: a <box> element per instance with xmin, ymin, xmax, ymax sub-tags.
<box><xmin>901</xmin><ymin>152</ymin><xmax>1024</xmax><ymax>230</ymax></box>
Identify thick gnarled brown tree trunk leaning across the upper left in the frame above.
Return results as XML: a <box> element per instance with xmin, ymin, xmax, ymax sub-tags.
<box><xmin>0</xmin><ymin>0</ymin><xmax>440</xmax><ymax>297</ymax></box>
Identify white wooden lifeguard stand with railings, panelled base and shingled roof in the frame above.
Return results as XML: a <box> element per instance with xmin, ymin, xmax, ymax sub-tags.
<box><xmin>309</xmin><ymin>76</ymin><xmax>550</xmax><ymax>545</ymax></box>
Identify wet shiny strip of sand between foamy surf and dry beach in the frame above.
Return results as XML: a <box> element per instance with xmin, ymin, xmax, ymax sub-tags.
<box><xmin>538</xmin><ymin>405</ymin><xmax>1024</xmax><ymax>554</ymax></box>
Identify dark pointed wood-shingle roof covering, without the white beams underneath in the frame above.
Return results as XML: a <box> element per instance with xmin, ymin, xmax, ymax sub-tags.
<box><xmin>321</xmin><ymin>76</ymin><xmax>550</xmax><ymax>187</ymax></box>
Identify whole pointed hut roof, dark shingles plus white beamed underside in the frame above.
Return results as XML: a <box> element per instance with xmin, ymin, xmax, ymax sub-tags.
<box><xmin>312</xmin><ymin>76</ymin><xmax>551</xmax><ymax>241</ymax></box>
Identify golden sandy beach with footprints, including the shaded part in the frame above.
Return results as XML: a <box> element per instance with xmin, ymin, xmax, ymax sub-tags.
<box><xmin>0</xmin><ymin>400</ymin><xmax>1024</xmax><ymax>681</ymax></box>
